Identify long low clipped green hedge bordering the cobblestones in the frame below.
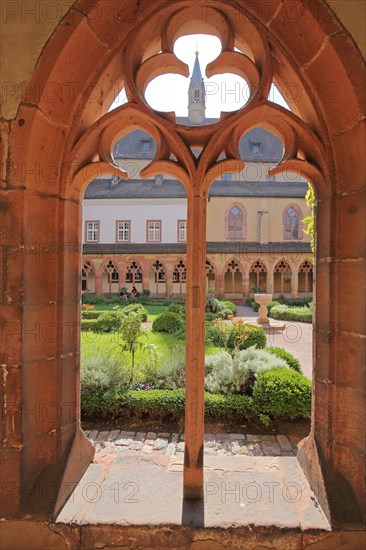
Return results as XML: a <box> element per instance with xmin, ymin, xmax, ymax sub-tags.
<box><xmin>81</xmin><ymin>387</ymin><xmax>255</xmax><ymax>422</ymax></box>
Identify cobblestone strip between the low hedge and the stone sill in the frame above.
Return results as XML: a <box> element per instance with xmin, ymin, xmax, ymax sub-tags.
<box><xmin>85</xmin><ymin>430</ymin><xmax>297</xmax><ymax>458</ymax></box>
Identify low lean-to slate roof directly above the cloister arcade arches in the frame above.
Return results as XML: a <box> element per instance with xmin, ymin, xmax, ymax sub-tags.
<box><xmin>83</xmin><ymin>241</ymin><xmax>311</xmax><ymax>259</ymax></box>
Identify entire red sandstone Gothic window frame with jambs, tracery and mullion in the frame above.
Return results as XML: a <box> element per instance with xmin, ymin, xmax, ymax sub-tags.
<box><xmin>1</xmin><ymin>0</ymin><xmax>366</xmax><ymax>532</ymax></box>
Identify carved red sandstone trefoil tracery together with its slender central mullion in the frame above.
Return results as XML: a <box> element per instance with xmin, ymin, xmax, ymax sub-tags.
<box><xmin>64</xmin><ymin>2</ymin><xmax>328</xmax><ymax>498</ymax></box>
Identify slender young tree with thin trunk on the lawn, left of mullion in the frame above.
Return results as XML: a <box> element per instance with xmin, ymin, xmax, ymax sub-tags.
<box><xmin>118</xmin><ymin>311</ymin><xmax>156</xmax><ymax>384</ymax></box>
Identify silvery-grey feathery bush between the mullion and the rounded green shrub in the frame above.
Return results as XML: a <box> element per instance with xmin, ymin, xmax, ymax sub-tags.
<box><xmin>205</xmin><ymin>347</ymin><xmax>288</xmax><ymax>395</ymax></box>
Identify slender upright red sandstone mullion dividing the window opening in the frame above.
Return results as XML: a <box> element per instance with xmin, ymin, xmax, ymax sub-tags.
<box><xmin>183</xmin><ymin>193</ymin><xmax>206</xmax><ymax>499</ymax></box>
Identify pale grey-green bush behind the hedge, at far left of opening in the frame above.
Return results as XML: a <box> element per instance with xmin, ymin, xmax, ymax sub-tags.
<box><xmin>80</xmin><ymin>354</ymin><xmax>128</xmax><ymax>389</ymax></box>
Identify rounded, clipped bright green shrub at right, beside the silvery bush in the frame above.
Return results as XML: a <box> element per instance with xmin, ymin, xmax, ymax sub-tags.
<box><xmin>253</xmin><ymin>369</ymin><xmax>311</xmax><ymax>418</ymax></box>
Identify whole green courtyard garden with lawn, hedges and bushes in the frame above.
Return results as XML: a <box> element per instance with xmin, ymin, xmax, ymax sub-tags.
<box><xmin>81</xmin><ymin>296</ymin><xmax>311</xmax><ymax>429</ymax></box>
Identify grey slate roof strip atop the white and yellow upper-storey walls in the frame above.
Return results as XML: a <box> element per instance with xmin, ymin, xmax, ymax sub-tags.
<box><xmin>84</xmin><ymin>179</ymin><xmax>307</xmax><ymax>199</ymax></box>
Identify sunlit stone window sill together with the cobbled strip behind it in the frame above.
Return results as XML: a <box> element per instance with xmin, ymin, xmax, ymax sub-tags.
<box><xmin>56</xmin><ymin>430</ymin><xmax>330</xmax><ymax>533</ymax></box>
